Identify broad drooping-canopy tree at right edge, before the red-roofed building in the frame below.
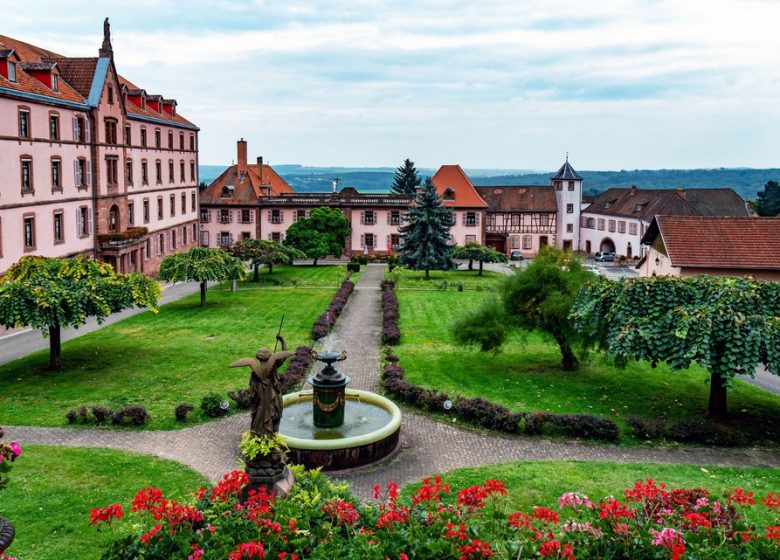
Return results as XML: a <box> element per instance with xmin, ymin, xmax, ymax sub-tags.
<box><xmin>571</xmin><ymin>276</ymin><xmax>780</xmax><ymax>419</ymax></box>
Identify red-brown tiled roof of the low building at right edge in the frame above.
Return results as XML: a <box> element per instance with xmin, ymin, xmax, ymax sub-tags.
<box><xmin>642</xmin><ymin>216</ymin><xmax>780</xmax><ymax>270</ymax></box>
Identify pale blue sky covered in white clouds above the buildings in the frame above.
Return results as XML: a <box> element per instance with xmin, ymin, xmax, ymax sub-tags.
<box><xmin>0</xmin><ymin>0</ymin><xmax>780</xmax><ymax>170</ymax></box>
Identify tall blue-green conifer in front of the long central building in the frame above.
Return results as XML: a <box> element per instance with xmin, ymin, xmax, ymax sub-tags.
<box><xmin>398</xmin><ymin>178</ymin><xmax>455</xmax><ymax>280</ymax></box>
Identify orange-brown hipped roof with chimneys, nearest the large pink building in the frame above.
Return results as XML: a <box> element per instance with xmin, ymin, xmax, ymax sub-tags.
<box><xmin>200</xmin><ymin>164</ymin><xmax>295</xmax><ymax>206</ymax></box>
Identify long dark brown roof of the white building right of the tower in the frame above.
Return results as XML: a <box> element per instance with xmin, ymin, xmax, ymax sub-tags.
<box><xmin>583</xmin><ymin>187</ymin><xmax>750</xmax><ymax>222</ymax></box>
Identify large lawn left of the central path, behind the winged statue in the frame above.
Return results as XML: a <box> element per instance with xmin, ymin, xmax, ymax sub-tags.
<box><xmin>0</xmin><ymin>284</ymin><xmax>335</xmax><ymax>429</ymax></box>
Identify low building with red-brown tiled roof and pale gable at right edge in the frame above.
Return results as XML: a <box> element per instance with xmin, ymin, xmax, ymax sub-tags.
<box><xmin>637</xmin><ymin>216</ymin><xmax>780</xmax><ymax>281</ymax></box>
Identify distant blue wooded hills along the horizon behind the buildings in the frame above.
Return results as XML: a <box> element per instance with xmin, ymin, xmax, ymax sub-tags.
<box><xmin>200</xmin><ymin>164</ymin><xmax>780</xmax><ymax>200</ymax></box>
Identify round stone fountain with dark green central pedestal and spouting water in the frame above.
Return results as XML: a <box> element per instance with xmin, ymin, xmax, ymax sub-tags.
<box><xmin>279</xmin><ymin>334</ymin><xmax>401</xmax><ymax>470</ymax></box>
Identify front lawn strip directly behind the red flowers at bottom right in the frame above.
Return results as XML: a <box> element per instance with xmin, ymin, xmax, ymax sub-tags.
<box><xmin>402</xmin><ymin>461</ymin><xmax>780</xmax><ymax>523</ymax></box>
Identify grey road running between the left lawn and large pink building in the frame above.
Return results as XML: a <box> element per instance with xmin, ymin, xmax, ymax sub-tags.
<box><xmin>0</xmin><ymin>282</ymin><xmax>200</xmax><ymax>365</ymax></box>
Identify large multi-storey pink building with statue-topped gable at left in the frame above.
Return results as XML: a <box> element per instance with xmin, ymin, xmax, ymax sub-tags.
<box><xmin>0</xmin><ymin>21</ymin><xmax>198</xmax><ymax>275</ymax></box>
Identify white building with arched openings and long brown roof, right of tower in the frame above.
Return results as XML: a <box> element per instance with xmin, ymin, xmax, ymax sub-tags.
<box><xmin>579</xmin><ymin>187</ymin><xmax>750</xmax><ymax>259</ymax></box>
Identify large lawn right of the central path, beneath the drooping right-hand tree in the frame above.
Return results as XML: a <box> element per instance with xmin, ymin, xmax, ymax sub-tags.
<box><xmin>396</xmin><ymin>290</ymin><xmax>780</xmax><ymax>444</ymax></box>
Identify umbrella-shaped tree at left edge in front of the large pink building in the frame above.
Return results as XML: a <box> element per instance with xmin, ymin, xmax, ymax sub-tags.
<box><xmin>0</xmin><ymin>255</ymin><xmax>160</xmax><ymax>370</ymax></box>
